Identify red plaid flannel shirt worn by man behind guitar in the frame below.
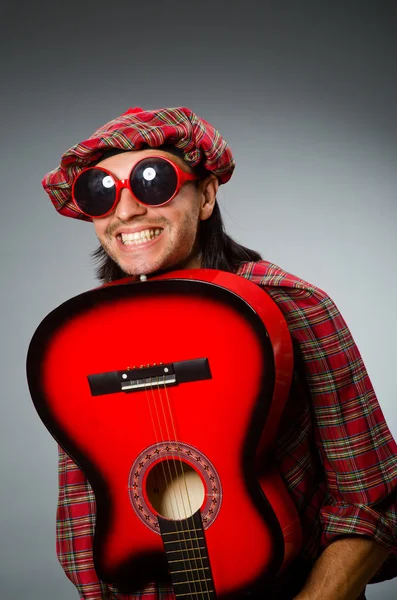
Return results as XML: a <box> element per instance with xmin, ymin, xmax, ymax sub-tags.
<box><xmin>57</xmin><ymin>261</ymin><xmax>397</xmax><ymax>600</ymax></box>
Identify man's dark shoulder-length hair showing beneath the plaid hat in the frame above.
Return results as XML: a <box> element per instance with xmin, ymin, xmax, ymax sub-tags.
<box><xmin>92</xmin><ymin>146</ymin><xmax>262</xmax><ymax>283</ymax></box>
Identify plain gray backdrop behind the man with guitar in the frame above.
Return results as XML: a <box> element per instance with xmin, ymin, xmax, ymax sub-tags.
<box><xmin>0</xmin><ymin>0</ymin><xmax>397</xmax><ymax>600</ymax></box>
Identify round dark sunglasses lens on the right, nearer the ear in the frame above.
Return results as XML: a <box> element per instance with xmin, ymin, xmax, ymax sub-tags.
<box><xmin>130</xmin><ymin>157</ymin><xmax>178</xmax><ymax>206</ymax></box>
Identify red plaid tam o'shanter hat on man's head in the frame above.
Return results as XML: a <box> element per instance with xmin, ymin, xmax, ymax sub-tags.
<box><xmin>42</xmin><ymin>108</ymin><xmax>235</xmax><ymax>221</ymax></box>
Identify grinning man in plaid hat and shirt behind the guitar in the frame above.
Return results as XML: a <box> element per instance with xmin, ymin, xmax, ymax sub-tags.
<box><xmin>43</xmin><ymin>108</ymin><xmax>397</xmax><ymax>600</ymax></box>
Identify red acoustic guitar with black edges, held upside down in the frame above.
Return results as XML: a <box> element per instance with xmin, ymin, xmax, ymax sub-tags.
<box><xmin>27</xmin><ymin>270</ymin><xmax>300</xmax><ymax>600</ymax></box>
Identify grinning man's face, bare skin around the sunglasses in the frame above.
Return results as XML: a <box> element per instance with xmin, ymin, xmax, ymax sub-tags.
<box><xmin>93</xmin><ymin>149</ymin><xmax>218</xmax><ymax>275</ymax></box>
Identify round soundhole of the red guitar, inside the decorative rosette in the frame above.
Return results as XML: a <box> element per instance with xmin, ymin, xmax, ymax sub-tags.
<box><xmin>146</xmin><ymin>458</ymin><xmax>205</xmax><ymax>521</ymax></box>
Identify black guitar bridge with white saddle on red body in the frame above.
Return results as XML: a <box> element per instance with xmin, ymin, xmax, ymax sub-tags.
<box><xmin>87</xmin><ymin>358</ymin><xmax>211</xmax><ymax>396</ymax></box>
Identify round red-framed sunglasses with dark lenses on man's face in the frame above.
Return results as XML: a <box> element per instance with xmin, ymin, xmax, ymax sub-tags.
<box><xmin>72</xmin><ymin>155</ymin><xmax>199</xmax><ymax>218</ymax></box>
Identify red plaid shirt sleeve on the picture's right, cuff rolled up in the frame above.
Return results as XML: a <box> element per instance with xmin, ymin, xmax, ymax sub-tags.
<box><xmin>267</xmin><ymin>287</ymin><xmax>397</xmax><ymax>553</ymax></box>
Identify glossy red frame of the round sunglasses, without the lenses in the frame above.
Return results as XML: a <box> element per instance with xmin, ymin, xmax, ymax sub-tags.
<box><xmin>72</xmin><ymin>154</ymin><xmax>200</xmax><ymax>219</ymax></box>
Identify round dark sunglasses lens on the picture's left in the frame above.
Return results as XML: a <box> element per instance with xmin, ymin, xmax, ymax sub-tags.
<box><xmin>73</xmin><ymin>169</ymin><xmax>116</xmax><ymax>217</ymax></box>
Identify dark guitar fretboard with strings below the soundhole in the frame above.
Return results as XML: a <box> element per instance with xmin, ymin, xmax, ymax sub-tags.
<box><xmin>158</xmin><ymin>510</ymin><xmax>216</xmax><ymax>600</ymax></box>
